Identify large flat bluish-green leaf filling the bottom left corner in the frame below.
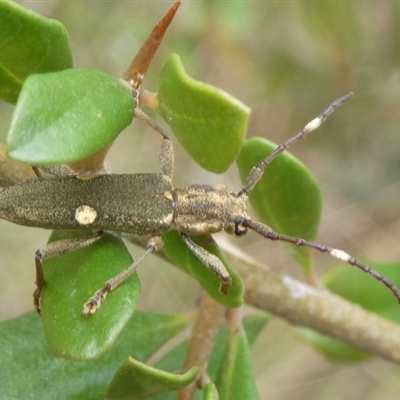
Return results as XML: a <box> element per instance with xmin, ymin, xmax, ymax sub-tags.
<box><xmin>0</xmin><ymin>311</ymin><xmax>189</xmax><ymax>400</ymax></box>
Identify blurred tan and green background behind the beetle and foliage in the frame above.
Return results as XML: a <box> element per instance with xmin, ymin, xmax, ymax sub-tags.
<box><xmin>0</xmin><ymin>0</ymin><xmax>400</xmax><ymax>400</ymax></box>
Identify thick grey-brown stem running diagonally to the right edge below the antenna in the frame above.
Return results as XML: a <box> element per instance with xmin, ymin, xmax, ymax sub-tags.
<box><xmin>227</xmin><ymin>255</ymin><xmax>400</xmax><ymax>364</ymax></box>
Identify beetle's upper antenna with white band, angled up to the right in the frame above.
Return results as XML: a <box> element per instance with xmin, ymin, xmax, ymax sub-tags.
<box><xmin>238</xmin><ymin>92</ymin><xmax>354</xmax><ymax>196</ymax></box>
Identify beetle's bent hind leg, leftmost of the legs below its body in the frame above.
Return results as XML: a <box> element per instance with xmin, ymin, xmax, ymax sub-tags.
<box><xmin>33</xmin><ymin>231</ymin><xmax>103</xmax><ymax>315</ymax></box>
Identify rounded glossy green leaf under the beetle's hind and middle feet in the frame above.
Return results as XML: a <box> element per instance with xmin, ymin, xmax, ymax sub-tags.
<box><xmin>42</xmin><ymin>230</ymin><xmax>140</xmax><ymax>360</ymax></box>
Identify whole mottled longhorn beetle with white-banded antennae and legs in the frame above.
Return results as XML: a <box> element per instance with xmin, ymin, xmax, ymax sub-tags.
<box><xmin>0</xmin><ymin>93</ymin><xmax>400</xmax><ymax>317</ymax></box>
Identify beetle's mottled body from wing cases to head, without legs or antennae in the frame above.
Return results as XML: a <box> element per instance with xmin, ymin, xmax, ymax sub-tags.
<box><xmin>0</xmin><ymin>174</ymin><xmax>248</xmax><ymax>235</ymax></box>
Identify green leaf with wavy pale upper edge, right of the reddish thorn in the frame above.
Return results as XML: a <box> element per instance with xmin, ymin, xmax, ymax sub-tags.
<box><xmin>154</xmin><ymin>54</ymin><xmax>250</xmax><ymax>173</ymax></box>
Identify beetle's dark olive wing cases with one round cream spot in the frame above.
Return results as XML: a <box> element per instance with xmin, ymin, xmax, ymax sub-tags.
<box><xmin>0</xmin><ymin>174</ymin><xmax>173</xmax><ymax>235</ymax></box>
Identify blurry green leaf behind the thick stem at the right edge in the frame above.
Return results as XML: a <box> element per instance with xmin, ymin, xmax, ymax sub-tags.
<box><xmin>298</xmin><ymin>263</ymin><xmax>400</xmax><ymax>362</ymax></box>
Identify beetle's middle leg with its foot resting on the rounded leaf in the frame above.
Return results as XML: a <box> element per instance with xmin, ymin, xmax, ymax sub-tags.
<box><xmin>82</xmin><ymin>236</ymin><xmax>164</xmax><ymax>318</ymax></box>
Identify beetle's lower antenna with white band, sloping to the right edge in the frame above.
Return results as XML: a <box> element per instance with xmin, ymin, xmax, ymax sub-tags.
<box><xmin>242</xmin><ymin>219</ymin><xmax>400</xmax><ymax>303</ymax></box>
